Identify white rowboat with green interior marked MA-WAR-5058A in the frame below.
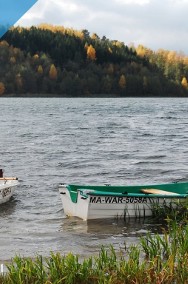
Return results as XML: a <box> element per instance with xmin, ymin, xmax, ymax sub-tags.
<box><xmin>59</xmin><ymin>183</ymin><xmax>188</xmax><ymax>220</ymax></box>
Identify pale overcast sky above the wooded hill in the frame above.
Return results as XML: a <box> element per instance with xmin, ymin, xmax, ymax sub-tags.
<box><xmin>17</xmin><ymin>0</ymin><xmax>188</xmax><ymax>55</ymax></box>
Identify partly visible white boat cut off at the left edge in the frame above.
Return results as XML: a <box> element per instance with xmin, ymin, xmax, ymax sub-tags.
<box><xmin>0</xmin><ymin>169</ymin><xmax>18</xmax><ymax>204</ymax></box>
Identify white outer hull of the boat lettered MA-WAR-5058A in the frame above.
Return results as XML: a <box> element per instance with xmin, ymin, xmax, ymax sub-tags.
<box><xmin>59</xmin><ymin>185</ymin><xmax>187</xmax><ymax>220</ymax></box>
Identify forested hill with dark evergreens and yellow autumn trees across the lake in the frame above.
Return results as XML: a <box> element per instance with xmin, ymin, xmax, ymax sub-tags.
<box><xmin>0</xmin><ymin>25</ymin><xmax>188</xmax><ymax>97</ymax></box>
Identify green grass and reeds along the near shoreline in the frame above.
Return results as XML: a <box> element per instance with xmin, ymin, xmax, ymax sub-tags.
<box><xmin>0</xmin><ymin>202</ymin><xmax>188</xmax><ymax>284</ymax></box>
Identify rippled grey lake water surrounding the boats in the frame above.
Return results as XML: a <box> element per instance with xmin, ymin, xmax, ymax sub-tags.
<box><xmin>0</xmin><ymin>98</ymin><xmax>188</xmax><ymax>260</ymax></box>
